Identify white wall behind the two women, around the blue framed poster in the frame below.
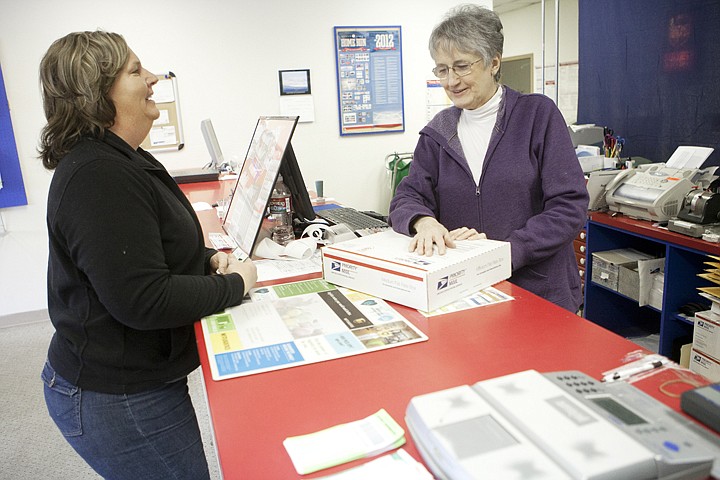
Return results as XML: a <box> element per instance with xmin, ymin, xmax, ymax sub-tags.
<box><xmin>0</xmin><ymin>0</ymin><xmax>577</xmax><ymax>316</ymax></box>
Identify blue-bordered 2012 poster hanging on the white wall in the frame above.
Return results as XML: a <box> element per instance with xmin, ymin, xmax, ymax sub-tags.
<box><xmin>335</xmin><ymin>26</ymin><xmax>405</xmax><ymax>135</ymax></box>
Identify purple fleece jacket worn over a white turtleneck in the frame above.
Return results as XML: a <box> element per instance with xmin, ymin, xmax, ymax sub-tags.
<box><xmin>390</xmin><ymin>87</ymin><xmax>588</xmax><ymax>312</ymax></box>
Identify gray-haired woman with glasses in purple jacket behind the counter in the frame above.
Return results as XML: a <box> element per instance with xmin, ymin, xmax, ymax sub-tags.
<box><xmin>390</xmin><ymin>5</ymin><xmax>588</xmax><ymax>312</ymax></box>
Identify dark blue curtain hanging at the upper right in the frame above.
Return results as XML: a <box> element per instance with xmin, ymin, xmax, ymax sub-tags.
<box><xmin>578</xmin><ymin>0</ymin><xmax>720</xmax><ymax>165</ymax></box>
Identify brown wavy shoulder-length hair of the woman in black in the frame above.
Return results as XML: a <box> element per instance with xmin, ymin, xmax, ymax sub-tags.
<box><xmin>38</xmin><ymin>31</ymin><xmax>130</xmax><ymax>170</ymax></box>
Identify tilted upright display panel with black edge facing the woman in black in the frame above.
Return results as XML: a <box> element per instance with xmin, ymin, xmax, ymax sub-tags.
<box><xmin>223</xmin><ymin>117</ymin><xmax>298</xmax><ymax>256</ymax></box>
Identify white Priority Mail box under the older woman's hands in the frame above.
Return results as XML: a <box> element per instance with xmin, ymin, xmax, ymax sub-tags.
<box><xmin>321</xmin><ymin>230</ymin><xmax>512</xmax><ymax>311</ymax></box>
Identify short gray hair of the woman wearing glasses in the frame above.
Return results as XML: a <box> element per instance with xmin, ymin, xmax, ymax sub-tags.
<box><xmin>429</xmin><ymin>4</ymin><xmax>505</xmax><ymax>81</ymax></box>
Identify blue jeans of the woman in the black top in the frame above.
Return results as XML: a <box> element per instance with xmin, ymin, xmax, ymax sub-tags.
<box><xmin>41</xmin><ymin>362</ymin><xmax>210</xmax><ymax>480</ymax></box>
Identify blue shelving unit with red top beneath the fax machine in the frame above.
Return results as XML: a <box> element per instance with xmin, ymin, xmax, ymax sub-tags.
<box><xmin>584</xmin><ymin>213</ymin><xmax>720</xmax><ymax>361</ymax></box>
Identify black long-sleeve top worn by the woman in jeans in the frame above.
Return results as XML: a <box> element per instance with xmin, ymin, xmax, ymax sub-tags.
<box><xmin>47</xmin><ymin>131</ymin><xmax>244</xmax><ymax>393</ymax></box>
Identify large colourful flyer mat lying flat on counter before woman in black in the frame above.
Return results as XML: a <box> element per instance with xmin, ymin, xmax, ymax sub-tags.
<box><xmin>202</xmin><ymin>279</ymin><xmax>427</xmax><ymax>380</ymax></box>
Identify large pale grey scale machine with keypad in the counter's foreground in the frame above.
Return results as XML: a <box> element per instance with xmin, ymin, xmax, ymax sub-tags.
<box><xmin>406</xmin><ymin>370</ymin><xmax>720</xmax><ymax>480</ymax></box>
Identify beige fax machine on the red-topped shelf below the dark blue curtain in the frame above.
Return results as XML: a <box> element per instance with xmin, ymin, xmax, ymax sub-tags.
<box><xmin>605</xmin><ymin>163</ymin><xmax>715</xmax><ymax>222</ymax></box>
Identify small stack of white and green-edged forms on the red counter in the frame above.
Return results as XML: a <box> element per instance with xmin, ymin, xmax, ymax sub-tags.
<box><xmin>283</xmin><ymin>409</ymin><xmax>405</xmax><ymax>475</ymax></box>
